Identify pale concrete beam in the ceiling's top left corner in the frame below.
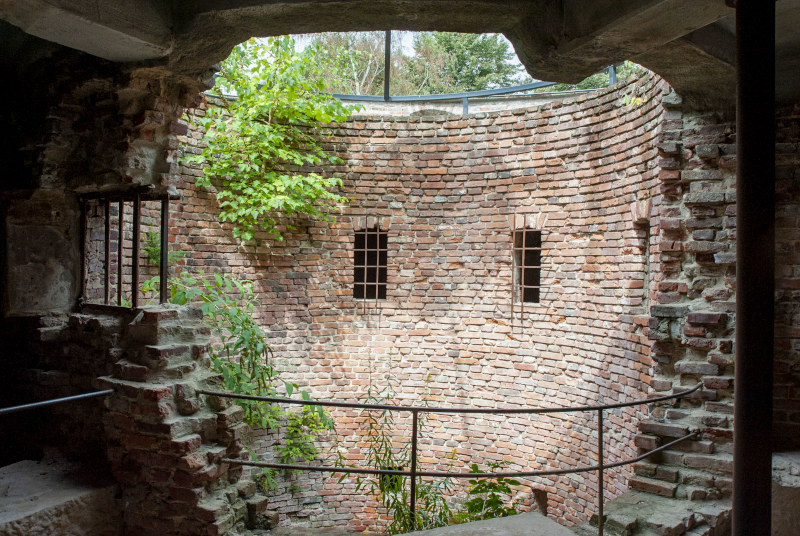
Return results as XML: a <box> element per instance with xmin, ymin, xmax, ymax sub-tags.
<box><xmin>0</xmin><ymin>0</ymin><xmax>172</xmax><ymax>62</ymax></box>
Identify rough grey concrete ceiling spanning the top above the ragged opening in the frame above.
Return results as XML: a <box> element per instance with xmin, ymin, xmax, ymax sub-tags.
<box><xmin>0</xmin><ymin>0</ymin><xmax>800</xmax><ymax>108</ymax></box>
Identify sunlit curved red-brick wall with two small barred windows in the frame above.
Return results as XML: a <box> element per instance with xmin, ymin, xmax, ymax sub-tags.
<box><xmin>173</xmin><ymin>75</ymin><xmax>666</xmax><ymax>529</ymax></box>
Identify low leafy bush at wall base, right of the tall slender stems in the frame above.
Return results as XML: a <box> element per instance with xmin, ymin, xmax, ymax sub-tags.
<box><xmin>455</xmin><ymin>462</ymin><xmax>522</xmax><ymax>523</ymax></box>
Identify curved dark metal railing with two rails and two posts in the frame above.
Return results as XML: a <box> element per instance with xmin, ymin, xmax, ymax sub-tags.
<box><xmin>197</xmin><ymin>384</ymin><xmax>702</xmax><ymax>536</ymax></box>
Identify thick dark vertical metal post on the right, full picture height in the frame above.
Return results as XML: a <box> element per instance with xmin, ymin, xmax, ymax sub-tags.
<box><xmin>732</xmin><ymin>0</ymin><xmax>775</xmax><ymax>536</ymax></box>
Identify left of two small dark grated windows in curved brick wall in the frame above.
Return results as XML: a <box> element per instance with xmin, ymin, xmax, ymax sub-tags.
<box><xmin>353</xmin><ymin>225</ymin><xmax>389</xmax><ymax>300</ymax></box>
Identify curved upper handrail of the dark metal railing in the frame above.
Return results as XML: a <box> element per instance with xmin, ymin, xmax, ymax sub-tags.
<box><xmin>197</xmin><ymin>383</ymin><xmax>703</xmax><ymax>415</ymax></box>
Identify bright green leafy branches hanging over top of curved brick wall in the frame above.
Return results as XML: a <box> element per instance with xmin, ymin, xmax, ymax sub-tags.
<box><xmin>185</xmin><ymin>37</ymin><xmax>360</xmax><ymax>240</ymax></box>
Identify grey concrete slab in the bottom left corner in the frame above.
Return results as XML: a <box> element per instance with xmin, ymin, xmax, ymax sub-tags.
<box><xmin>0</xmin><ymin>460</ymin><xmax>122</xmax><ymax>536</ymax></box>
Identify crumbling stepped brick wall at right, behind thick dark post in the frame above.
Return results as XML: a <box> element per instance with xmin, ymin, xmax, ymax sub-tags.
<box><xmin>630</xmin><ymin>99</ymin><xmax>800</xmax><ymax>506</ymax></box>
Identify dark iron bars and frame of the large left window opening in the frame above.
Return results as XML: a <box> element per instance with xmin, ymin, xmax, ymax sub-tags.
<box><xmin>80</xmin><ymin>186</ymin><xmax>170</xmax><ymax>308</ymax></box>
